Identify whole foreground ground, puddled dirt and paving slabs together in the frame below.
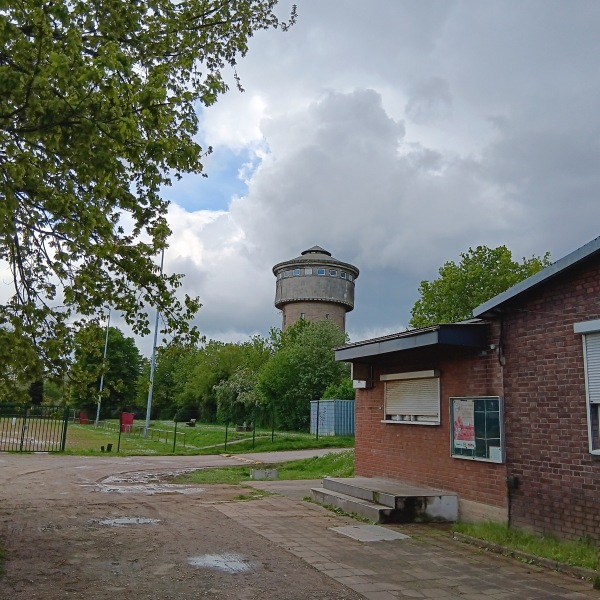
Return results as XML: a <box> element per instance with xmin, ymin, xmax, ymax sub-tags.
<box><xmin>0</xmin><ymin>451</ymin><xmax>600</xmax><ymax>600</ymax></box>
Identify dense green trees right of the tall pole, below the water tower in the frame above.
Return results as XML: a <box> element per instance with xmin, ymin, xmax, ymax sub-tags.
<box><xmin>138</xmin><ymin>321</ymin><xmax>354</xmax><ymax>430</ymax></box>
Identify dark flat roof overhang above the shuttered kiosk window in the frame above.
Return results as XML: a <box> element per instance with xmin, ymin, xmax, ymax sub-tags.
<box><xmin>335</xmin><ymin>320</ymin><xmax>488</xmax><ymax>362</ymax></box>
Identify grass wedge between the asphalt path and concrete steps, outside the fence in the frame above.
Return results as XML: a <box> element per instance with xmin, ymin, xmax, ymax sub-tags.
<box><xmin>174</xmin><ymin>450</ymin><xmax>354</xmax><ymax>484</ymax></box>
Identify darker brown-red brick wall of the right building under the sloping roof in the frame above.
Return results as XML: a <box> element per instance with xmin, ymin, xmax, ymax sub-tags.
<box><xmin>504</xmin><ymin>265</ymin><xmax>600</xmax><ymax>541</ymax></box>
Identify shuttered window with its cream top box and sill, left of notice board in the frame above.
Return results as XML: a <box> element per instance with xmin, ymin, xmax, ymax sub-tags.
<box><xmin>380</xmin><ymin>370</ymin><xmax>441</xmax><ymax>425</ymax></box>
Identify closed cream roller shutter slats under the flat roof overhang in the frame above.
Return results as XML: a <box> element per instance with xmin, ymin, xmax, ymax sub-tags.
<box><xmin>385</xmin><ymin>374</ymin><xmax>440</xmax><ymax>425</ymax></box>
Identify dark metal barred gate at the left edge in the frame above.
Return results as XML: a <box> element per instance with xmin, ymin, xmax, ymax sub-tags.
<box><xmin>0</xmin><ymin>404</ymin><xmax>69</xmax><ymax>452</ymax></box>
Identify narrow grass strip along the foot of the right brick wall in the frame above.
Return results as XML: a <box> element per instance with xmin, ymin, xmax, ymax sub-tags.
<box><xmin>454</xmin><ymin>522</ymin><xmax>599</xmax><ymax>569</ymax></box>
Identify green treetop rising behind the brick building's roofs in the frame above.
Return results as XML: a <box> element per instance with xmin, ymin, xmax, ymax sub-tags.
<box><xmin>410</xmin><ymin>246</ymin><xmax>551</xmax><ymax>327</ymax></box>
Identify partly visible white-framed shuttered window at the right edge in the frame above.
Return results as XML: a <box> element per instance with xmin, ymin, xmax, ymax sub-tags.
<box><xmin>573</xmin><ymin>319</ymin><xmax>600</xmax><ymax>455</ymax></box>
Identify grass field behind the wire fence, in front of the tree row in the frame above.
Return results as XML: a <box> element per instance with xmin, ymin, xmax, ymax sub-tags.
<box><xmin>65</xmin><ymin>421</ymin><xmax>354</xmax><ymax>455</ymax></box>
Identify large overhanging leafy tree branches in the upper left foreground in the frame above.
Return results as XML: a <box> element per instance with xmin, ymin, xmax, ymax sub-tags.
<box><xmin>0</xmin><ymin>0</ymin><xmax>295</xmax><ymax>378</ymax></box>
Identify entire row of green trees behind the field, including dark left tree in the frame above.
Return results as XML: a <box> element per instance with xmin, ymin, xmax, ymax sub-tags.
<box><xmin>0</xmin><ymin>321</ymin><xmax>354</xmax><ymax>430</ymax></box>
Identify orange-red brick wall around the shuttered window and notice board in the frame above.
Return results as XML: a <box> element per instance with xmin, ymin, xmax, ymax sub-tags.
<box><xmin>356</xmin><ymin>336</ymin><xmax>507</xmax><ymax>507</ymax></box>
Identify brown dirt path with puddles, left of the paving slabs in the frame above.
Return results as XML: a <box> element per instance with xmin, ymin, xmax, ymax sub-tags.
<box><xmin>0</xmin><ymin>453</ymin><xmax>361</xmax><ymax>600</ymax></box>
